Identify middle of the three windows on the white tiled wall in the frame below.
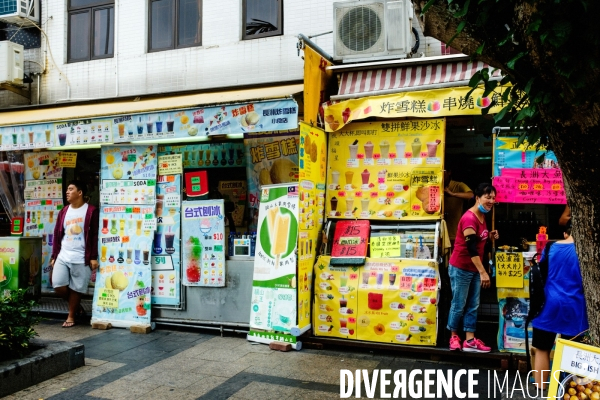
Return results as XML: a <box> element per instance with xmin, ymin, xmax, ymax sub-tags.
<box><xmin>148</xmin><ymin>0</ymin><xmax>202</xmax><ymax>51</ymax></box>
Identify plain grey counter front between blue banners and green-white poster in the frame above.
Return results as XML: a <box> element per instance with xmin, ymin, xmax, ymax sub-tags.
<box><xmin>152</xmin><ymin>258</ymin><xmax>254</xmax><ymax>327</ymax></box>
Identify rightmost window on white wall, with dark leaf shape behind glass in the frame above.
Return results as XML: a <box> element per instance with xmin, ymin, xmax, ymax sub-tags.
<box><xmin>242</xmin><ymin>0</ymin><xmax>283</xmax><ymax>40</ymax></box>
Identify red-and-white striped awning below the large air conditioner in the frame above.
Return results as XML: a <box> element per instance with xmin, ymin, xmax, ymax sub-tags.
<box><xmin>338</xmin><ymin>61</ymin><xmax>500</xmax><ymax>97</ymax></box>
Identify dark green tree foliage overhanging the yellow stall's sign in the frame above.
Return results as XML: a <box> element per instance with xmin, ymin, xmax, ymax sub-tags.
<box><xmin>422</xmin><ymin>0</ymin><xmax>600</xmax><ymax>146</ymax></box>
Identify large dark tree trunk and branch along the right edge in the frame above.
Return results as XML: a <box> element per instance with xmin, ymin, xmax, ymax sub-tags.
<box><xmin>414</xmin><ymin>0</ymin><xmax>600</xmax><ymax>346</ymax></box>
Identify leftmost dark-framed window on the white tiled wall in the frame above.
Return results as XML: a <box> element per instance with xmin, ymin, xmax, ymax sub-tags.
<box><xmin>67</xmin><ymin>0</ymin><xmax>115</xmax><ymax>62</ymax></box>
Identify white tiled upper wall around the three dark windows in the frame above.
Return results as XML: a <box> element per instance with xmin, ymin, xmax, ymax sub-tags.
<box><xmin>0</xmin><ymin>0</ymin><xmax>333</xmax><ymax>107</ymax></box>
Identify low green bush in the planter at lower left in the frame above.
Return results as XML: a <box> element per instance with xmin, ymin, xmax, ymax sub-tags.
<box><xmin>0</xmin><ymin>289</ymin><xmax>40</xmax><ymax>359</ymax></box>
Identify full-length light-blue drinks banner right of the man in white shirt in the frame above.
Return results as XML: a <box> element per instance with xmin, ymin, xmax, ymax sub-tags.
<box><xmin>92</xmin><ymin>145</ymin><xmax>157</xmax><ymax>328</ymax></box>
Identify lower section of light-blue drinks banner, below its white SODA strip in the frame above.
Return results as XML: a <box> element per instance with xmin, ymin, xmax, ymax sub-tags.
<box><xmin>92</xmin><ymin>205</ymin><xmax>154</xmax><ymax>327</ymax></box>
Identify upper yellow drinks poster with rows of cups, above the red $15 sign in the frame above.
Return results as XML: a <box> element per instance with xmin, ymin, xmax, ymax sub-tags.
<box><xmin>326</xmin><ymin>118</ymin><xmax>446</xmax><ymax>221</ymax></box>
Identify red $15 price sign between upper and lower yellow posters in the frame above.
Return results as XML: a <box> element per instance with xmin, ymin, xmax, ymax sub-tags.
<box><xmin>331</xmin><ymin>220</ymin><xmax>371</xmax><ymax>265</ymax></box>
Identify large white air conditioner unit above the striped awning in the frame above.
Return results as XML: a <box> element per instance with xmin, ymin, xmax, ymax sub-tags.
<box><xmin>333</xmin><ymin>0</ymin><xmax>414</xmax><ymax>61</ymax></box>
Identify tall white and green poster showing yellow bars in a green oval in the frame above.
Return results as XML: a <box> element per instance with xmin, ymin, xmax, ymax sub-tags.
<box><xmin>250</xmin><ymin>184</ymin><xmax>298</xmax><ymax>333</ymax></box>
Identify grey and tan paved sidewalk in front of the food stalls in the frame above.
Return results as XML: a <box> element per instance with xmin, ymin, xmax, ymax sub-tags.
<box><xmin>5</xmin><ymin>319</ymin><xmax>540</xmax><ymax>400</ymax></box>
